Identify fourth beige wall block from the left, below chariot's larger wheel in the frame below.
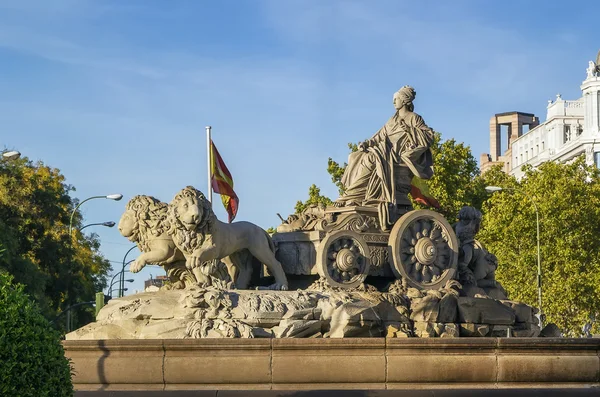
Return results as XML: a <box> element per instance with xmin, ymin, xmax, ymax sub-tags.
<box><xmin>387</xmin><ymin>338</ymin><xmax>496</xmax><ymax>382</ymax></box>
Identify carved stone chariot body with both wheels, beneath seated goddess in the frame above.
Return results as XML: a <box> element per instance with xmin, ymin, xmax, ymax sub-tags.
<box><xmin>272</xmin><ymin>207</ymin><xmax>459</xmax><ymax>289</ymax></box>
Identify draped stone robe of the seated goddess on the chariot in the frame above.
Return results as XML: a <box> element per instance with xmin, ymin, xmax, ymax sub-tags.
<box><xmin>340</xmin><ymin>112</ymin><xmax>434</xmax><ymax>205</ymax></box>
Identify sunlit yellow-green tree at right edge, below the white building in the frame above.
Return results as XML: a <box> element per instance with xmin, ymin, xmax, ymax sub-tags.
<box><xmin>478</xmin><ymin>158</ymin><xmax>600</xmax><ymax>336</ymax></box>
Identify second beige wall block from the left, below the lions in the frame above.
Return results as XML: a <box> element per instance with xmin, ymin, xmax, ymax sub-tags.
<box><xmin>164</xmin><ymin>339</ymin><xmax>271</xmax><ymax>389</ymax></box>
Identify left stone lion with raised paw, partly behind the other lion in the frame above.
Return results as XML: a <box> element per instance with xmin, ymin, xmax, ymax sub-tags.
<box><xmin>119</xmin><ymin>195</ymin><xmax>195</xmax><ymax>288</ymax></box>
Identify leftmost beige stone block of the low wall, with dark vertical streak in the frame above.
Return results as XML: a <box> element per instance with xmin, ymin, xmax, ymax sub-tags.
<box><xmin>63</xmin><ymin>339</ymin><xmax>164</xmax><ymax>390</ymax></box>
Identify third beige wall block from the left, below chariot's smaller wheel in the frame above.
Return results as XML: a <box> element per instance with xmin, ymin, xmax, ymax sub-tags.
<box><xmin>272</xmin><ymin>338</ymin><xmax>385</xmax><ymax>388</ymax></box>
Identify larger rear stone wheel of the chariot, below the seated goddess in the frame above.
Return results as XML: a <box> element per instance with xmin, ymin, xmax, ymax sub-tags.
<box><xmin>388</xmin><ymin>210</ymin><xmax>458</xmax><ymax>289</ymax></box>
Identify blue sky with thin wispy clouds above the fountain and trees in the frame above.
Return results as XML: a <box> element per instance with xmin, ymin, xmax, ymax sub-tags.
<box><xmin>0</xmin><ymin>0</ymin><xmax>600</xmax><ymax>291</ymax></box>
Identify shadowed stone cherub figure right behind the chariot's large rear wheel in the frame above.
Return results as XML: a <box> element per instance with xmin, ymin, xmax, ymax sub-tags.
<box><xmin>455</xmin><ymin>206</ymin><xmax>507</xmax><ymax>299</ymax></box>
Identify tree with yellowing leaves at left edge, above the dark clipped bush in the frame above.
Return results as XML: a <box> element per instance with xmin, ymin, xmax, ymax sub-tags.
<box><xmin>0</xmin><ymin>158</ymin><xmax>110</xmax><ymax>330</ymax></box>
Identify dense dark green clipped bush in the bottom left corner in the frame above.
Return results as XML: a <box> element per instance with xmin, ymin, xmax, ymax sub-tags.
<box><xmin>0</xmin><ymin>273</ymin><xmax>73</xmax><ymax>397</ymax></box>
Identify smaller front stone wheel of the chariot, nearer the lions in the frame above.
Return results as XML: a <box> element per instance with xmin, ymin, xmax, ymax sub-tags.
<box><xmin>317</xmin><ymin>230</ymin><xmax>370</xmax><ymax>288</ymax></box>
